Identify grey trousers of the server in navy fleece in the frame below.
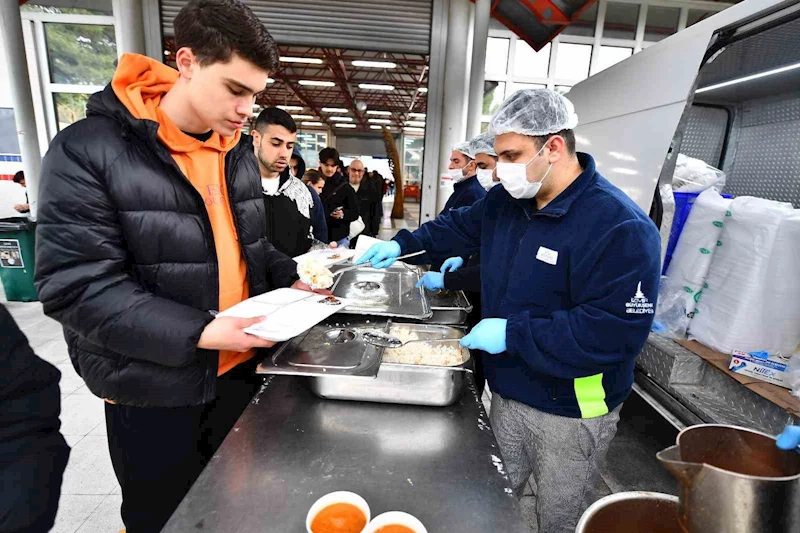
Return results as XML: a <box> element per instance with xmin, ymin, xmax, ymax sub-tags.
<box><xmin>489</xmin><ymin>394</ymin><xmax>622</xmax><ymax>533</ymax></box>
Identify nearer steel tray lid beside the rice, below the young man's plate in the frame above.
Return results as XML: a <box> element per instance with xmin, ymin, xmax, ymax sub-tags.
<box><xmin>256</xmin><ymin>315</ymin><xmax>387</xmax><ymax>378</ymax></box>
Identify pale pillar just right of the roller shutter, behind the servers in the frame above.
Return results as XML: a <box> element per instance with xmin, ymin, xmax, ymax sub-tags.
<box><xmin>437</xmin><ymin>0</ymin><xmax>471</xmax><ymax>212</ymax></box>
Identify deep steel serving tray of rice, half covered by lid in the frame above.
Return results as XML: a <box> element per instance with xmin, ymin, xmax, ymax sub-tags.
<box><xmin>310</xmin><ymin>323</ymin><xmax>470</xmax><ymax>407</ymax></box>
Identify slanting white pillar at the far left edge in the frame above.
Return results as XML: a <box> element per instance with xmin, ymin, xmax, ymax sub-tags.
<box><xmin>0</xmin><ymin>1</ymin><xmax>42</xmax><ymax>220</ymax></box>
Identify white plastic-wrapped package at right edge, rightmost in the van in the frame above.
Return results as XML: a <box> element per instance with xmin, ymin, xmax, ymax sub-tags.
<box><xmin>689</xmin><ymin>197</ymin><xmax>800</xmax><ymax>355</ymax></box>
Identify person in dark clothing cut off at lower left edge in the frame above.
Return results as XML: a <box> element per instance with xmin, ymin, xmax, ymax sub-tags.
<box><xmin>0</xmin><ymin>305</ymin><xmax>70</xmax><ymax>533</ymax></box>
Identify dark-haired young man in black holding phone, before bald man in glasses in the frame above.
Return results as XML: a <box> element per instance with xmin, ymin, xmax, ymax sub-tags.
<box><xmin>319</xmin><ymin>147</ymin><xmax>358</xmax><ymax>248</ymax></box>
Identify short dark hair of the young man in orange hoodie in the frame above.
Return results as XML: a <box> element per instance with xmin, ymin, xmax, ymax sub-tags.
<box><xmin>173</xmin><ymin>0</ymin><xmax>279</xmax><ymax>71</ymax></box>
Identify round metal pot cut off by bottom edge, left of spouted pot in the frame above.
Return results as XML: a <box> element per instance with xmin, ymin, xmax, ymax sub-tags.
<box><xmin>575</xmin><ymin>492</ymin><xmax>681</xmax><ymax>533</ymax></box>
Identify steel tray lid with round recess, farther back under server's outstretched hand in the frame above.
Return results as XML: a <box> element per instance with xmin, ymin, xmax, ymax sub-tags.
<box><xmin>331</xmin><ymin>263</ymin><xmax>433</xmax><ymax>320</ymax></box>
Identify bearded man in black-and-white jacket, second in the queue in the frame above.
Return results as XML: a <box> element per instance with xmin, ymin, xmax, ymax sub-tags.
<box><xmin>252</xmin><ymin>107</ymin><xmax>327</xmax><ymax>257</ymax></box>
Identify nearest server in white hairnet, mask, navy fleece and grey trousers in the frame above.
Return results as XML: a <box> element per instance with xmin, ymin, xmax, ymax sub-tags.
<box><xmin>361</xmin><ymin>89</ymin><xmax>660</xmax><ymax>533</ymax></box>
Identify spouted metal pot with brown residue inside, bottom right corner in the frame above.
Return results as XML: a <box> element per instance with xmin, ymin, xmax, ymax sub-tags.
<box><xmin>656</xmin><ymin>424</ymin><xmax>800</xmax><ymax>533</ymax></box>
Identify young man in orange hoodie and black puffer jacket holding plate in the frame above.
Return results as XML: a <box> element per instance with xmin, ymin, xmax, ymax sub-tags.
<box><xmin>35</xmin><ymin>0</ymin><xmax>322</xmax><ymax>533</ymax></box>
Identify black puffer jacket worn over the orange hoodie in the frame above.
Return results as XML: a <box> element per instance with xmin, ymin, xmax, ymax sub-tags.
<box><xmin>36</xmin><ymin>86</ymin><xmax>297</xmax><ymax>407</ymax></box>
